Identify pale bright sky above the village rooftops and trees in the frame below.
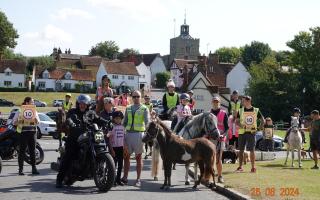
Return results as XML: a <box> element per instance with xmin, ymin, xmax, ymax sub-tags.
<box><xmin>0</xmin><ymin>0</ymin><xmax>320</xmax><ymax>56</ymax></box>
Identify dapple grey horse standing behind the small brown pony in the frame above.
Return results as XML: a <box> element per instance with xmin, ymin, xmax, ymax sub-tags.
<box><xmin>152</xmin><ymin>112</ymin><xmax>220</xmax><ymax>185</ymax></box>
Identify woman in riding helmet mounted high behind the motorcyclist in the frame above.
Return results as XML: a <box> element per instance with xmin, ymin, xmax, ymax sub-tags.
<box><xmin>96</xmin><ymin>75</ymin><xmax>113</xmax><ymax>113</ymax></box>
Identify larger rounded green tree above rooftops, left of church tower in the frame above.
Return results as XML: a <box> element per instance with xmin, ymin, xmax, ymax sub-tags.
<box><xmin>89</xmin><ymin>40</ymin><xmax>119</xmax><ymax>59</ymax></box>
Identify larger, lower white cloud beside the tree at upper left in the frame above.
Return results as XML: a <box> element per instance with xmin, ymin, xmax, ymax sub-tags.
<box><xmin>22</xmin><ymin>24</ymin><xmax>73</xmax><ymax>46</ymax></box>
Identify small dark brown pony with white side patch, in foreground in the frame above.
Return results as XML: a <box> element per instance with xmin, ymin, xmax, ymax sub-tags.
<box><xmin>142</xmin><ymin>119</ymin><xmax>216</xmax><ymax>190</ymax></box>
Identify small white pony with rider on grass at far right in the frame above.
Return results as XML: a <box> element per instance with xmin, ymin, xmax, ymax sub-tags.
<box><xmin>284</xmin><ymin>116</ymin><xmax>302</xmax><ymax>168</ymax></box>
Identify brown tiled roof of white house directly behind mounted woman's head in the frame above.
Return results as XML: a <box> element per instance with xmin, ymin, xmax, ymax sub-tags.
<box><xmin>103</xmin><ymin>61</ymin><xmax>139</xmax><ymax>76</ymax></box>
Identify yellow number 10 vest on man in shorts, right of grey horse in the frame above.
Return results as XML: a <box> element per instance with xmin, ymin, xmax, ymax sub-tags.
<box><xmin>239</xmin><ymin>107</ymin><xmax>259</xmax><ymax>134</ymax></box>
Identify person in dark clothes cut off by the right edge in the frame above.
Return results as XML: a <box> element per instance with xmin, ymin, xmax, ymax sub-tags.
<box><xmin>307</xmin><ymin>110</ymin><xmax>320</xmax><ymax>169</ymax></box>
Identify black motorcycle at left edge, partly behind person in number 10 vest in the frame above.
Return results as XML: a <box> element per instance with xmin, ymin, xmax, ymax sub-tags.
<box><xmin>0</xmin><ymin>124</ymin><xmax>44</xmax><ymax>166</ymax></box>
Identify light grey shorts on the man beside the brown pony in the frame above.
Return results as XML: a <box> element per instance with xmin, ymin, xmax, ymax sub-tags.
<box><xmin>124</xmin><ymin>132</ymin><xmax>144</xmax><ymax>155</ymax></box>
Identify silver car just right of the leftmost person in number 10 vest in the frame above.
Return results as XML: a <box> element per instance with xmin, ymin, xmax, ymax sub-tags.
<box><xmin>37</xmin><ymin>113</ymin><xmax>57</xmax><ymax>139</ymax></box>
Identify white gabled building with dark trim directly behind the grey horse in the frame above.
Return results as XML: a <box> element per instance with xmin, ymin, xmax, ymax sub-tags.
<box><xmin>188</xmin><ymin>71</ymin><xmax>230</xmax><ymax>112</ymax></box>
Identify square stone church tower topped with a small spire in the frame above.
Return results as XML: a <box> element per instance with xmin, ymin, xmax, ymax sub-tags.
<box><xmin>170</xmin><ymin>11</ymin><xmax>200</xmax><ymax>61</ymax></box>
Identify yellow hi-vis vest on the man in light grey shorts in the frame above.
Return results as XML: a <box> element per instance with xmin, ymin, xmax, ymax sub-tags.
<box><xmin>126</xmin><ymin>105</ymin><xmax>147</xmax><ymax>132</ymax></box>
